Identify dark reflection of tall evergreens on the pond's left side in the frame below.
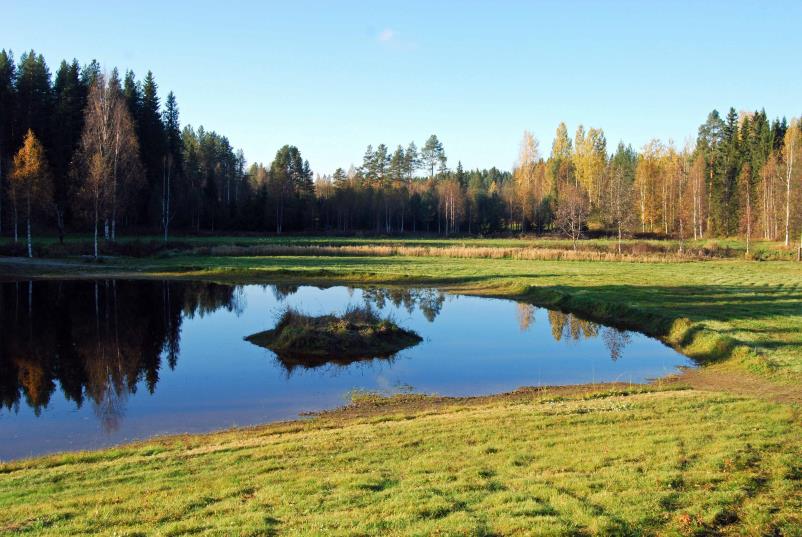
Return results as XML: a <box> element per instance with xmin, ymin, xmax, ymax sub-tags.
<box><xmin>0</xmin><ymin>280</ymin><xmax>242</xmax><ymax>431</ymax></box>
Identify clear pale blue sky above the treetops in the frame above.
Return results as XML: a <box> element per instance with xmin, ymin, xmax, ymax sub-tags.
<box><xmin>0</xmin><ymin>0</ymin><xmax>802</xmax><ymax>172</ymax></box>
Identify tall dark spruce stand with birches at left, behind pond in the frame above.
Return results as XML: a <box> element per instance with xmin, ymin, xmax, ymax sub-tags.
<box><xmin>0</xmin><ymin>50</ymin><xmax>245</xmax><ymax>255</ymax></box>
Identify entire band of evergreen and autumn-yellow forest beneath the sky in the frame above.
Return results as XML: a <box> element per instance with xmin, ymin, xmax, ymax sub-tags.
<box><xmin>0</xmin><ymin>50</ymin><xmax>802</xmax><ymax>256</ymax></box>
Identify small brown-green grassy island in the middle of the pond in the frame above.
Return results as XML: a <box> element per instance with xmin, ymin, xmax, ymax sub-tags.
<box><xmin>245</xmin><ymin>306</ymin><xmax>422</xmax><ymax>369</ymax></box>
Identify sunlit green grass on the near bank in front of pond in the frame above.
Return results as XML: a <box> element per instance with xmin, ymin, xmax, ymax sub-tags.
<box><xmin>0</xmin><ymin>390</ymin><xmax>802</xmax><ymax>536</ymax></box>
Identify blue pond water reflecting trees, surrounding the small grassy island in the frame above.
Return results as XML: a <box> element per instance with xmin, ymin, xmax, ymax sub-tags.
<box><xmin>0</xmin><ymin>280</ymin><xmax>692</xmax><ymax>460</ymax></box>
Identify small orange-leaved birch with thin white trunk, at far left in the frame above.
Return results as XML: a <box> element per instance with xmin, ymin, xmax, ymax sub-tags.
<box><xmin>11</xmin><ymin>129</ymin><xmax>53</xmax><ymax>257</ymax></box>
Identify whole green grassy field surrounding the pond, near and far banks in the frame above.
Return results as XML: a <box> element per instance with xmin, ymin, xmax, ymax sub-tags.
<box><xmin>0</xmin><ymin>239</ymin><xmax>802</xmax><ymax>536</ymax></box>
